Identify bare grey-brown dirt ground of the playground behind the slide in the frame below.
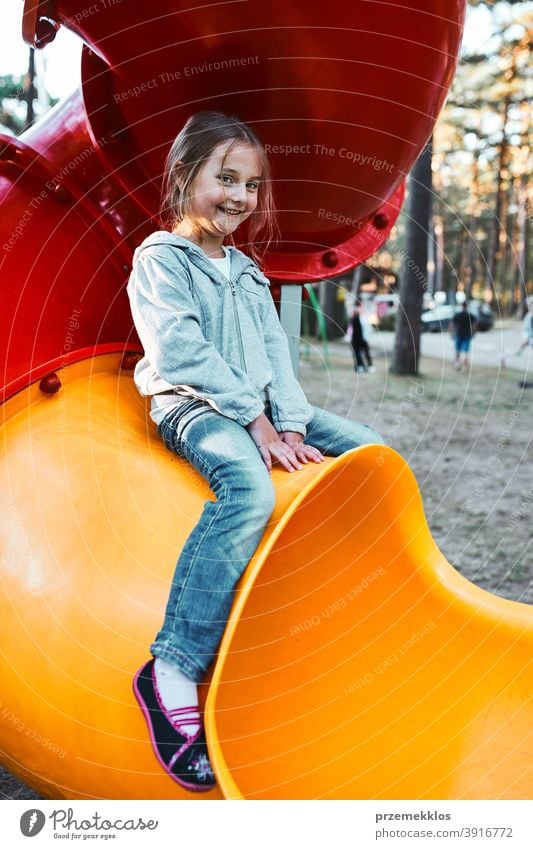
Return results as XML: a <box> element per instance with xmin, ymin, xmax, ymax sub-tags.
<box><xmin>0</xmin><ymin>342</ymin><xmax>533</xmax><ymax>799</ymax></box>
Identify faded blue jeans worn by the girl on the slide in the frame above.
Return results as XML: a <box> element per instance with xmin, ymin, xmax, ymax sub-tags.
<box><xmin>150</xmin><ymin>399</ymin><xmax>383</xmax><ymax>681</ymax></box>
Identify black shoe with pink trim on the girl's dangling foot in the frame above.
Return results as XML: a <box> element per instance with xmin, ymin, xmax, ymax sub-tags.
<box><xmin>133</xmin><ymin>659</ymin><xmax>216</xmax><ymax>792</ymax></box>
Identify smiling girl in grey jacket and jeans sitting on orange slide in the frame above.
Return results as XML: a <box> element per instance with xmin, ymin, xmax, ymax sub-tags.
<box><xmin>128</xmin><ymin>112</ymin><xmax>383</xmax><ymax>790</ymax></box>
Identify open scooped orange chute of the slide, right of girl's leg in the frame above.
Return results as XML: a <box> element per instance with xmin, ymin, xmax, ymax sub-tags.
<box><xmin>206</xmin><ymin>446</ymin><xmax>533</xmax><ymax>799</ymax></box>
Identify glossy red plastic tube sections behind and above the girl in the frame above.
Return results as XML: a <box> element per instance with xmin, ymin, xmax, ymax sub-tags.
<box><xmin>0</xmin><ymin>0</ymin><xmax>465</xmax><ymax>396</ymax></box>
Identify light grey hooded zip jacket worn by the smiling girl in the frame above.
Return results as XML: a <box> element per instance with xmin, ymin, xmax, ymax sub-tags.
<box><xmin>127</xmin><ymin>231</ymin><xmax>313</xmax><ymax>435</ymax></box>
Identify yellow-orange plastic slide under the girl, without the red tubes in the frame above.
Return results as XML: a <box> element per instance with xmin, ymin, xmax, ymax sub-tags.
<box><xmin>0</xmin><ymin>352</ymin><xmax>533</xmax><ymax>801</ymax></box>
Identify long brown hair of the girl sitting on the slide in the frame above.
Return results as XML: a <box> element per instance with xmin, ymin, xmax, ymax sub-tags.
<box><xmin>160</xmin><ymin>112</ymin><xmax>278</xmax><ymax>262</ymax></box>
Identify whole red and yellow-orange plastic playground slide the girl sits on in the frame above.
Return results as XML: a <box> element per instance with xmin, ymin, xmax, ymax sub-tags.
<box><xmin>0</xmin><ymin>0</ymin><xmax>533</xmax><ymax>799</ymax></box>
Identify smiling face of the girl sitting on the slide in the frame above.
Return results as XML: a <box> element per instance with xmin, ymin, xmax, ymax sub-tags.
<box><xmin>181</xmin><ymin>142</ymin><xmax>261</xmax><ymax>244</ymax></box>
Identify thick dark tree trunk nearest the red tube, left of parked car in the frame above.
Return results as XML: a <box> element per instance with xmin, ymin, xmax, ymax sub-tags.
<box><xmin>392</xmin><ymin>142</ymin><xmax>432</xmax><ymax>374</ymax></box>
